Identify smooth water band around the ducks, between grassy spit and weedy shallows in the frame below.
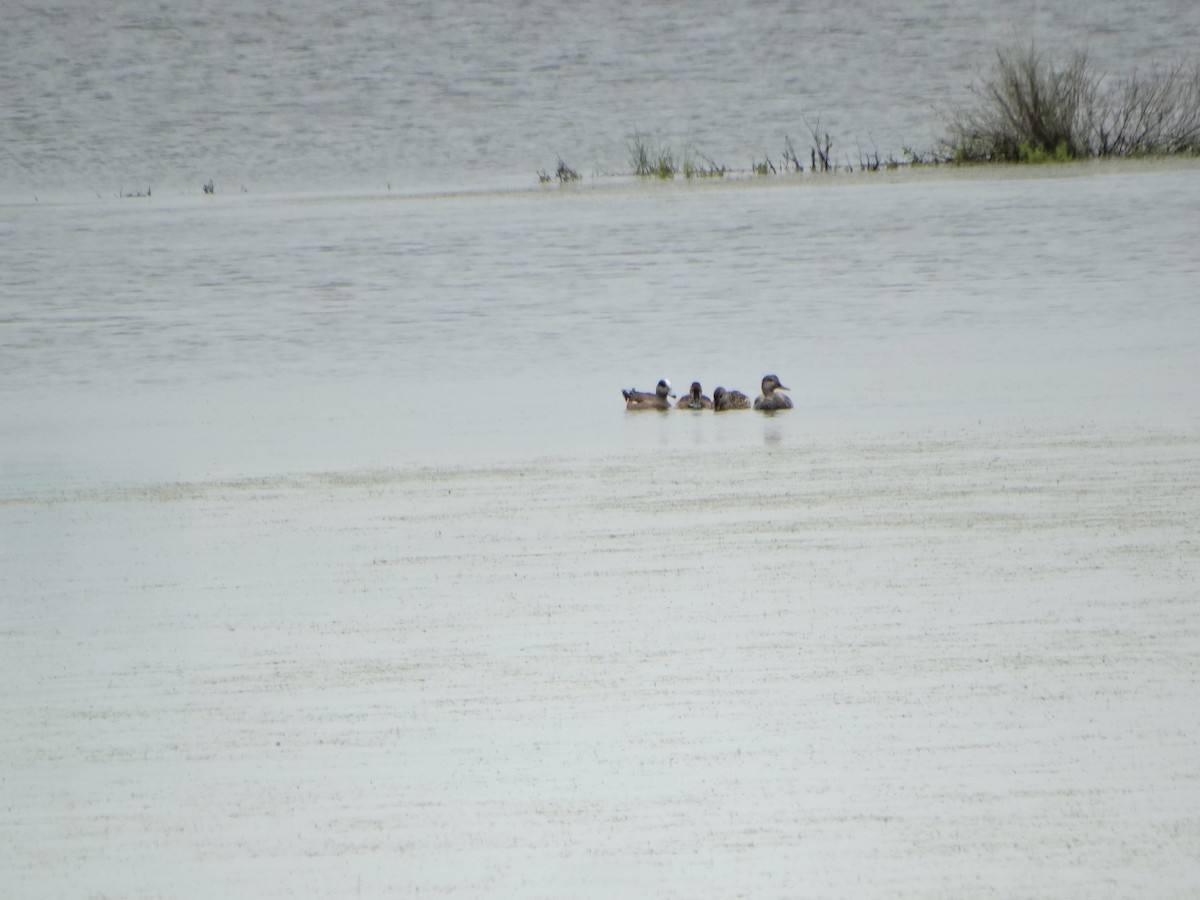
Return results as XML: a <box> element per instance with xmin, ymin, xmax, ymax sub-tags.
<box><xmin>0</xmin><ymin>166</ymin><xmax>1200</xmax><ymax>496</ymax></box>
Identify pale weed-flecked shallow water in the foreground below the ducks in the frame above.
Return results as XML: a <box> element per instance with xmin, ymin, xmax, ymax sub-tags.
<box><xmin>0</xmin><ymin>426</ymin><xmax>1200</xmax><ymax>900</ymax></box>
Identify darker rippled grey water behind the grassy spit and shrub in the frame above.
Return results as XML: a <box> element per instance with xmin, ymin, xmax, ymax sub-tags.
<box><xmin>0</xmin><ymin>0</ymin><xmax>1200</xmax><ymax>200</ymax></box>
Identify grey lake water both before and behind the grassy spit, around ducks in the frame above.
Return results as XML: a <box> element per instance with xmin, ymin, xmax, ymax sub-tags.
<box><xmin>0</xmin><ymin>1</ymin><xmax>1200</xmax><ymax>494</ymax></box>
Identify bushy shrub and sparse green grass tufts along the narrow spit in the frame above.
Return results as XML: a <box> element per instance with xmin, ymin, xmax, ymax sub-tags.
<box><xmin>538</xmin><ymin>43</ymin><xmax>1200</xmax><ymax>185</ymax></box>
